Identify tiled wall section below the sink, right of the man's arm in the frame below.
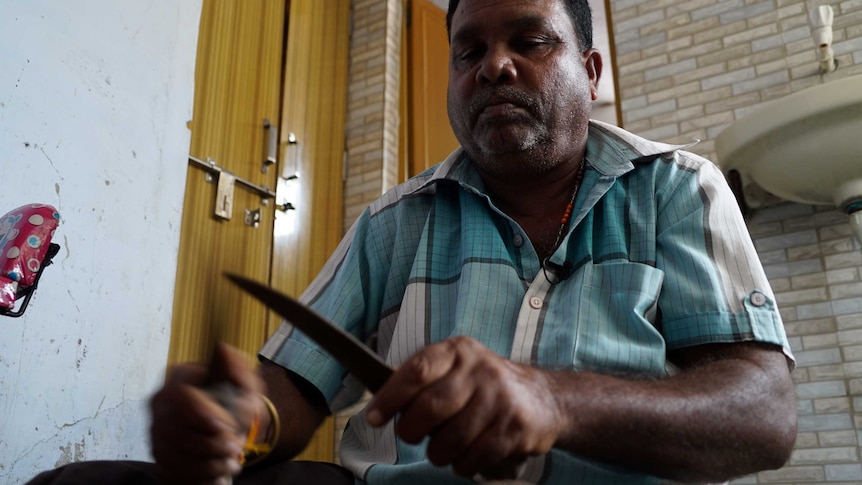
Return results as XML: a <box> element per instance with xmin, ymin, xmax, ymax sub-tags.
<box><xmin>734</xmin><ymin>203</ymin><xmax>862</xmax><ymax>484</ymax></box>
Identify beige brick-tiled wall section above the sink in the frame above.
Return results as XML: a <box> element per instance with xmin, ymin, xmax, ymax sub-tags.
<box><xmin>610</xmin><ymin>0</ymin><xmax>862</xmax><ymax>159</ymax></box>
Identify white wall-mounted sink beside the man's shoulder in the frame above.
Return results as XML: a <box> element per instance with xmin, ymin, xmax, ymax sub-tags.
<box><xmin>715</xmin><ymin>76</ymin><xmax>862</xmax><ymax>207</ymax></box>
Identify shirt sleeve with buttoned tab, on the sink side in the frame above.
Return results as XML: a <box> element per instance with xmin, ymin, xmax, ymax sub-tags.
<box><xmin>656</xmin><ymin>152</ymin><xmax>793</xmax><ymax>359</ymax></box>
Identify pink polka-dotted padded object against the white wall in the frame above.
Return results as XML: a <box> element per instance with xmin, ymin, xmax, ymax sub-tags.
<box><xmin>0</xmin><ymin>204</ymin><xmax>60</xmax><ymax>317</ymax></box>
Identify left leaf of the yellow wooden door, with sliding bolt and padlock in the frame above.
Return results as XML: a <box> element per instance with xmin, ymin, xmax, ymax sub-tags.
<box><xmin>169</xmin><ymin>0</ymin><xmax>285</xmax><ymax>363</ymax></box>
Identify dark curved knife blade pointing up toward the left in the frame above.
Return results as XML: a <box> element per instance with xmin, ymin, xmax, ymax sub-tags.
<box><xmin>225</xmin><ymin>273</ymin><xmax>392</xmax><ymax>392</ymax></box>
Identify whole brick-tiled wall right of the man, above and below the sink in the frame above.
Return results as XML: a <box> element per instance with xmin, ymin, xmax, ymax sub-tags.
<box><xmin>610</xmin><ymin>0</ymin><xmax>862</xmax><ymax>484</ymax></box>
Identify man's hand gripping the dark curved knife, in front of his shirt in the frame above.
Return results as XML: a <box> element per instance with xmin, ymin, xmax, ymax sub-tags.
<box><xmin>366</xmin><ymin>337</ymin><xmax>558</xmax><ymax>479</ymax></box>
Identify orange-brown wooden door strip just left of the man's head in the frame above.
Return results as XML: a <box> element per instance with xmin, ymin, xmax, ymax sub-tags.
<box><xmin>402</xmin><ymin>0</ymin><xmax>458</xmax><ymax>176</ymax></box>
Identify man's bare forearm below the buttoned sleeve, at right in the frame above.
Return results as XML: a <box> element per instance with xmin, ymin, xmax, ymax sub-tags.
<box><xmin>548</xmin><ymin>344</ymin><xmax>796</xmax><ymax>482</ymax></box>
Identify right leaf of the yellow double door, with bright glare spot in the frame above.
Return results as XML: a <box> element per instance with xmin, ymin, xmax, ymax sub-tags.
<box><xmin>269</xmin><ymin>0</ymin><xmax>350</xmax><ymax>461</ymax></box>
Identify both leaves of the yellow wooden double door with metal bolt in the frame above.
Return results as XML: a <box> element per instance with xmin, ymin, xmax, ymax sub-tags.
<box><xmin>169</xmin><ymin>0</ymin><xmax>350</xmax><ymax>461</ymax></box>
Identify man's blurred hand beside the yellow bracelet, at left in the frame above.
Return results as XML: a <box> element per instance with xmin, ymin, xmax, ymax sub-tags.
<box><xmin>150</xmin><ymin>344</ymin><xmax>267</xmax><ymax>485</ymax></box>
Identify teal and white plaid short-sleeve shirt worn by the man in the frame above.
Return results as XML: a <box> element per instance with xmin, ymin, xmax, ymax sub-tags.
<box><xmin>261</xmin><ymin>122</ymin><xmax>791</xmax><ymax>484</ymax></box>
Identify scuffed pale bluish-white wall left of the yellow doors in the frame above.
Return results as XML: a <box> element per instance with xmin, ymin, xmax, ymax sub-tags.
<box><xmin>0</xmin><ymin>0</ymin><xmax>201</xmax><ymax>484</ymax></box>
